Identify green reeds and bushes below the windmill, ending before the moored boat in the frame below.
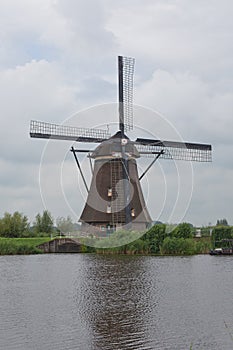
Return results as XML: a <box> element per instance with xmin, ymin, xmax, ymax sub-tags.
<box><xmin>83</xmin><ymin>225</ymin><xmax>212</xmax><ymax>255</ymax></box>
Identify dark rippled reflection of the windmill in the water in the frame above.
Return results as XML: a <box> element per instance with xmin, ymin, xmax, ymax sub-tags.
<box><xmin>76</xmin><ymin>256</ymin><xmax>155</xmax><ymax>350</ymax></box>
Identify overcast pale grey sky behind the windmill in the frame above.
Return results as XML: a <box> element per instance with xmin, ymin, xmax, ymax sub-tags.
<box><xmin>0</xmin><ymin>0</ymin><xmax>233</xmax><ymax>226</ymax></box>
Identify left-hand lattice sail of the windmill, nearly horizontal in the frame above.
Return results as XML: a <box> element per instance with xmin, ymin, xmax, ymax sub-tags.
<box><xmin>30</xmin><ymin>120</ymin><xmax>111</xmax><ymax>142</ymax></box>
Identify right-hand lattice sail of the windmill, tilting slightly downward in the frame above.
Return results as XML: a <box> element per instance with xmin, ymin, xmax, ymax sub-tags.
<box><xmin>135</xmin><ymin>138</ymin><xmax>212</xmax><ymax>162</ymax></box>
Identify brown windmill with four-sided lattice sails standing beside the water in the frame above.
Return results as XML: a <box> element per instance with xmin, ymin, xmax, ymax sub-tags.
<box><xmin>30</xmin><ymin>56</ymin><xmax>211</xmax><ymax>236</ymax></box>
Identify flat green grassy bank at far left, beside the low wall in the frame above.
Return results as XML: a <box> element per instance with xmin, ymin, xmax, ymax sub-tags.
<box><xmin>0</xmin><ymin>237</ymin><xmax>50</xmax><ymax>255</ymax></box>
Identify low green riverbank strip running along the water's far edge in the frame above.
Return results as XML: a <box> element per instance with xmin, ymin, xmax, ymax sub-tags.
<box><xmin>0</xmin><ymin>237</ymin><xmax>212</xmax><ymax>256</ymax></box>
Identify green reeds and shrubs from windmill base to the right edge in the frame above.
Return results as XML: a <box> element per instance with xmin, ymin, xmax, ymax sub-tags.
<box><xmin>84</xmin><ymin>223</ymin><xmax>233</xmax><ymax>255</ymax></box>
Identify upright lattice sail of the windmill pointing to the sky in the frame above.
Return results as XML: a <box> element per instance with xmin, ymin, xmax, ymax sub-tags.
<box><xmin>118</xmin><ymin>56</ymin><xmax>135</xmax><ymax>134</ymax></box>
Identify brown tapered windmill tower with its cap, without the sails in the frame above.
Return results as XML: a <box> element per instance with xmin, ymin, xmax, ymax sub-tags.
<box><xmin>80</xmin><ymin>131</ymin><xmax>151</xmax><ymax>235</ymax></box>
